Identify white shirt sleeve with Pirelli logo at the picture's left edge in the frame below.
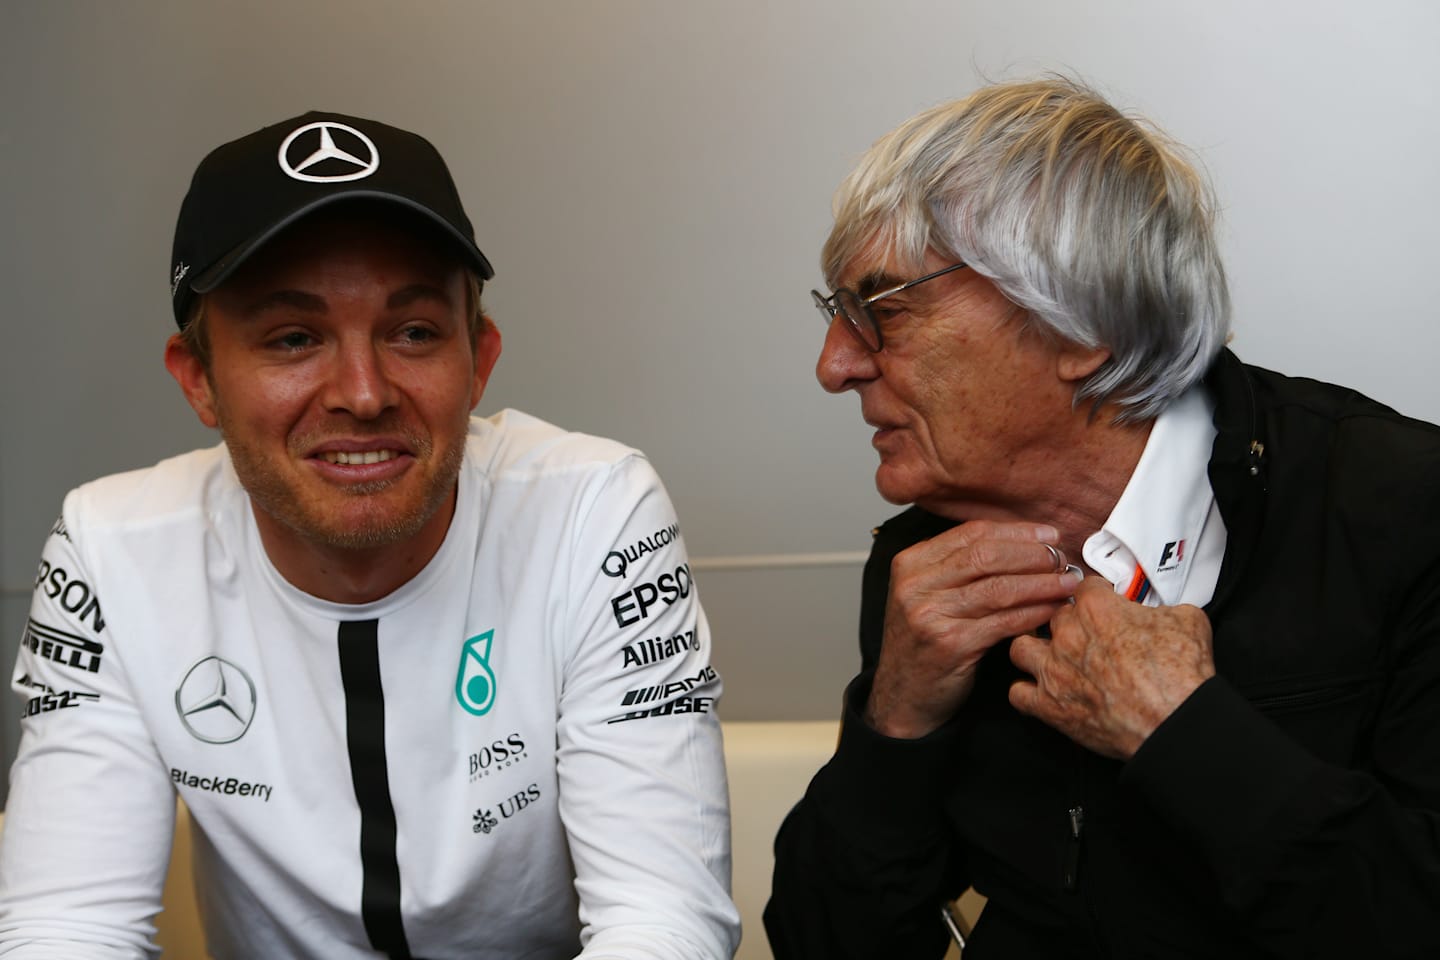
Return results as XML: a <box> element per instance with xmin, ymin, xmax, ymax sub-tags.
<box><xmin>0</xmin><ymin>494</ymin><xmax>176</xmax><ymax>960</ymax></box>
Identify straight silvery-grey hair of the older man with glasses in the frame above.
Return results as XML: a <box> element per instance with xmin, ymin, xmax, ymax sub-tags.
<box><xmin>821</xmin><ymin>78</ymin><xmax>1230</xmax><ymax>422</ymax></box>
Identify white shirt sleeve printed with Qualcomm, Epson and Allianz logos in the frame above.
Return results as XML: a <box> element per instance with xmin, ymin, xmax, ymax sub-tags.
<box><xmin>557</xmin><ymin>455</ymin><xmax>740</xmax><ymax>960</ymax></box>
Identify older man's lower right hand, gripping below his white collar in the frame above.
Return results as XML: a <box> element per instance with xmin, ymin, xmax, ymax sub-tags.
<box><xmin>1009</xmin><ymin>577</ymin><xmax>1215</xmax><ymax>760</ymax></box>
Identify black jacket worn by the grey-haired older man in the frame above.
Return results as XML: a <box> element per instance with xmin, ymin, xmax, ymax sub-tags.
<box><xmin>765</xmin><ymin>351</ymin><xmax>1440</xmax><ymax>960</ymax></box>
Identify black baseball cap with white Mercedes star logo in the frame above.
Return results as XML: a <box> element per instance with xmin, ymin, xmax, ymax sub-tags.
<box><xmin>170</xmin><ymin>111</ymin><xmax>495</xmax><ymax>330</ymax></box>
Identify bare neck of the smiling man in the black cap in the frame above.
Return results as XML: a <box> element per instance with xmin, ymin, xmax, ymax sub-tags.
<box><xmin>251</xmin><ymin>494</ymin><xmax>455</xmax><ymax>603</ymax></box>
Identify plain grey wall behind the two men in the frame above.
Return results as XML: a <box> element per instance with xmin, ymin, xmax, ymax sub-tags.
<box><xmin>0</xmin><ymin>0</ymin><xmax>1440</xmax><ymax>788</ymax></box>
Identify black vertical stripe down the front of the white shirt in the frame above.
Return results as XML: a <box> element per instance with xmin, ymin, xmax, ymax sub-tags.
<box><xmin>340</xmin><ymin>620</ymin><xmax>410</xmax><ymax>960</ymax></box>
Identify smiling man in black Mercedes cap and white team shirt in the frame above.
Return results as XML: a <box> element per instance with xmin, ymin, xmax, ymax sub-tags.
<box><xmin>0</xmin><ymin>114</ymin><xmax>739</xmax><ymax>959</ymax></box>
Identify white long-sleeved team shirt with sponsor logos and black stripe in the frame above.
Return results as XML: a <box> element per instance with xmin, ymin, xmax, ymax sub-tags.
<box><xmin>0</xmin><ymin>412</ymin><xmax>739</xmax><ymax>960</ymax></box>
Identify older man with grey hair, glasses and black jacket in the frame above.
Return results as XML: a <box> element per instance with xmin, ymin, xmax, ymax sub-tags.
<box><xmin>766</xmin><ymin>79</ymin><xmax>1440</xmax><ymax>960</ymax></box>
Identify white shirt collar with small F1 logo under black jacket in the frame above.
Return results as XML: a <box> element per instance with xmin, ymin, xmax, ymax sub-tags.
<box><xmin>1081</xmin><ymin>387</ymin><xmax>1225</xmax><ymax>606</ymax></box>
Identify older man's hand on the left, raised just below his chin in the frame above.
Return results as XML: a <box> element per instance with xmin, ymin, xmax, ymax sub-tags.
<box><xmin>865</xmin><ymin>521</ymin><xmax>1079</xmax><ymax>738</ymax></box>
